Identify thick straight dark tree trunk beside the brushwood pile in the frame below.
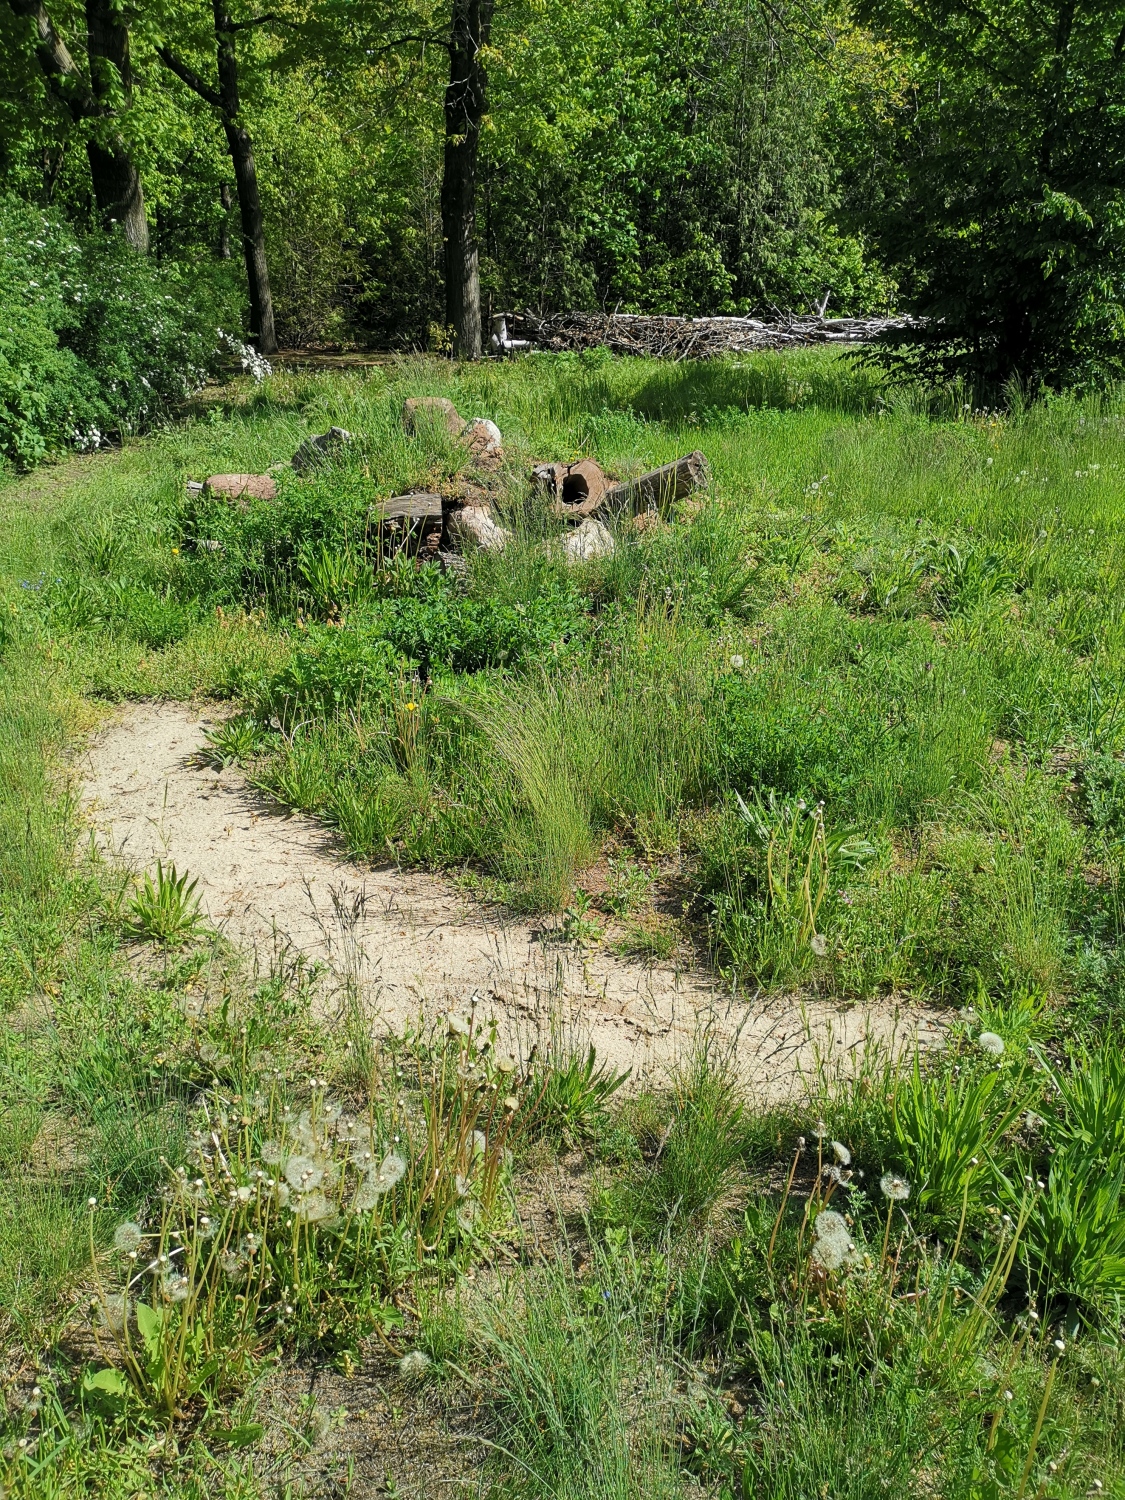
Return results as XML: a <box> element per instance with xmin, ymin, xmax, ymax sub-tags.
<box><xmin>441</xmin><ymin>0</ymin><xmax>494</xmax><ymax>360</ymax></box>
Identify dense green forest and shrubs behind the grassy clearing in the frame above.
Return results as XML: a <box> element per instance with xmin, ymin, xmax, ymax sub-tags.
<box><xmin>0</xmin><ymin>0</ymin><xmax>1125</xmax><ymax>467</ymax></box>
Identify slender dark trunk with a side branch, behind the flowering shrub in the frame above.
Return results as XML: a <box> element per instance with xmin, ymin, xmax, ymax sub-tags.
<box><xmin>158</xmin><ymin>0</ymin><xmax>278</xmax><ymax>354</ymax></box>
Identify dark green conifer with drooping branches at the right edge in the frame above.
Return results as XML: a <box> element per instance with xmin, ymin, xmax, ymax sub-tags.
<box><xmin>857</xmin><ymin>0</ymin><xmax>1125</xmax><ymax>395</ymax></box>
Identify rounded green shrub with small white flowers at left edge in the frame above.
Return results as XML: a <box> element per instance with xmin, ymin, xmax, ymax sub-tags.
<box><xmin>0</xmin><ymin>198</ymin><xmax>244</xmax><ymax>468</ymax></box>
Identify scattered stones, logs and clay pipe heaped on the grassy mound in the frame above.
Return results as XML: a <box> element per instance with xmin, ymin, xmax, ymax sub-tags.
<box><xmin>188</xmin><ymin>396</ymin><xmax>710</xmax><ymax>569</ymax></box>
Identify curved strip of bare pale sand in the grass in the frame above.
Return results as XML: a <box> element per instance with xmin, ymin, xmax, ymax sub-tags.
<box><xmin>78</xmin><ymin>704</ymin><xmax>939</xmax><ymax>1098</ymax></box>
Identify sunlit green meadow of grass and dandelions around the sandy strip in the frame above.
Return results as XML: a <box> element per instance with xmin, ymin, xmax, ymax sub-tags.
<box><xmin>0</xmin><ymin>351</ymin><xmax>1125</xmax><ymax>1500</ymax></box>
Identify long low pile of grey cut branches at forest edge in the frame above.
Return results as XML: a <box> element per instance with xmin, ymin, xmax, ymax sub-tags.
<box><xmin>504</xmin><ymin>312</ymin><xmax>909</xmax><ymax>360</ymax></box>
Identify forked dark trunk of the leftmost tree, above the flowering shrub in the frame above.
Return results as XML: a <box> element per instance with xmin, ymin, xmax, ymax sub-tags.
<box><xmin>9</xmin><ymin>0</ymin><xmax>149</xmax><ymax>254</ymax></box>
